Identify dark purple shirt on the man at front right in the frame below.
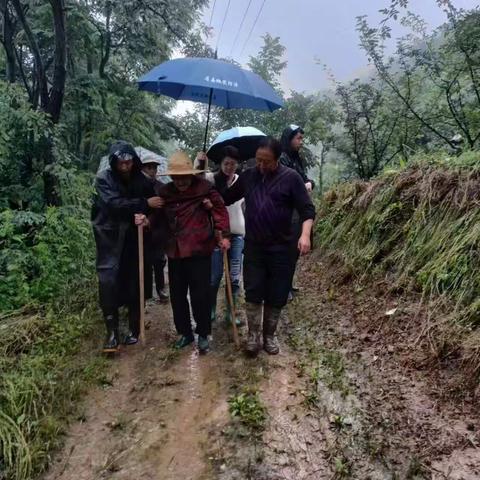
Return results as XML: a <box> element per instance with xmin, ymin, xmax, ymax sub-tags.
<box><xmin>222</xmin><ymin>165</ymin><xmax>315</xmax><ymax>246</ymax></box>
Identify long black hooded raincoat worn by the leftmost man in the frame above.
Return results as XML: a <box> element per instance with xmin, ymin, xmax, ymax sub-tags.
<box><xmin>92</xmin><ymin>142</ymin><xmax>154</xmax><ymax>310</ymax></box>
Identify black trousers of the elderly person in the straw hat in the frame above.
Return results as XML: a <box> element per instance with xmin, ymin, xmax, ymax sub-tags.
<box><xmin>168</xmin><ymin>256</ymin><xmax>212</xmax><ymax>337</ymax></box>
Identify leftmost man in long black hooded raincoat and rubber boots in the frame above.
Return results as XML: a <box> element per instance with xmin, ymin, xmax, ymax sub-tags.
<box><xmin>92</xmin><ymin>141</ymin><xmax>163</xmax><ymax>352</ymax></box>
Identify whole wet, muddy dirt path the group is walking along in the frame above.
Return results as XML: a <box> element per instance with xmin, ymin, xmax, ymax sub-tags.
<box><xmin>42</xmin><ymin>259</ymin><xmax>480</xmax><ymax>480</ymax></box>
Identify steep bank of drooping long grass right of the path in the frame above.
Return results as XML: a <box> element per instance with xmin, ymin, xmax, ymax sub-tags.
<box><xmin>316</xmin><ymin>152</ymin><xmax>480</xmax><ymax>376</ymax></box>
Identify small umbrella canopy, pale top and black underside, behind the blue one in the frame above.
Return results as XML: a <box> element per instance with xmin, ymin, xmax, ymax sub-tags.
<box><xmin>207</xmin><ymin>127</ymin><xmax>265</xmax><ymax>163</ymax></box>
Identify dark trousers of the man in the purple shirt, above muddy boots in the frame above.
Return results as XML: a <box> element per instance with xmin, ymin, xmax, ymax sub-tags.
<box><xmin>243</xmin><ymin>242</ymin><xmax>292</xmax><ymax>308</ymax></box>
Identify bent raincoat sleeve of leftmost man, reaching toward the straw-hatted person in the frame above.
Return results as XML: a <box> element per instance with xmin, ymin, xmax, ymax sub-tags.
<box><xmin>95</xmin><ymin>176</ymin><xmax>148</xmax><ymax>220</ymax></box>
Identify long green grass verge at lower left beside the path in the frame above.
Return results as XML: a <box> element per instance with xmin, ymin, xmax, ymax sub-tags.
<box><xmin>0</xmin><ymin>288</ymin><xmax>104</xmax><ymax>480</ymax></box>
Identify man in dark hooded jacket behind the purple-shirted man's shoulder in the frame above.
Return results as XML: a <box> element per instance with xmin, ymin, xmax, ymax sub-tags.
<box><xmin>280</xmin><ymin>125</ymin><xmax>315</xmax><ymax>300</ymax></box>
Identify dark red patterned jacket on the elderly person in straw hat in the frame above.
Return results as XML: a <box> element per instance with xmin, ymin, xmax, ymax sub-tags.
<box><xmin>150</xmin><ymin>177</ymin><xmax>230</xmax><ymax>258</ymax></box>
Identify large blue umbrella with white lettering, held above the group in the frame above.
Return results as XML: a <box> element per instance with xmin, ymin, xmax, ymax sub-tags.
<box><xmin>138</xmin><ymin>58</ymin><xmax>283</xmax><ymax>150</ymax></box>
